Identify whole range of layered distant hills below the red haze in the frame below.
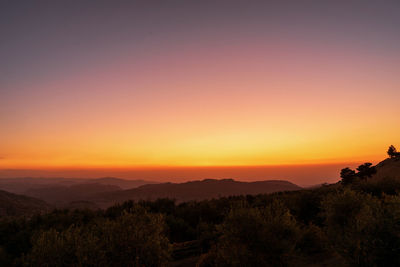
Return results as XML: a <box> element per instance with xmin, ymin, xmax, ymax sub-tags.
<box><xmin>0</xmin><ymin>177</ymin><xmax>301</xmax><ymax>208</ymax></box>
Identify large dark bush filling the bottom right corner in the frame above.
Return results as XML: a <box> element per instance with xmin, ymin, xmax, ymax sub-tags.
<box><xmin>323</xmin><ymin>189</ymin><xmax>400</xmax><ymax>266</ymax></box>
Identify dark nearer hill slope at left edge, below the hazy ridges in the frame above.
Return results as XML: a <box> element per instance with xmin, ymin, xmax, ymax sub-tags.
<box><xmin>0</xmin><ymin>190</ymin><xmax>51</xmax><ymax>217</ymax></box>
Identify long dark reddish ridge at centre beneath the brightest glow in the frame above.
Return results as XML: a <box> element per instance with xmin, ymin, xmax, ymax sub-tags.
<box><xmin>95</xmin><ymin>179</ymin><xmax>301</xmax><ymax>206</ymax></box>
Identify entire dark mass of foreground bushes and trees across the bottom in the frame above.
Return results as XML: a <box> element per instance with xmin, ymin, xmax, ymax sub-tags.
<box><xmin>0</xmin><ymin>148</ymin><xmax>400</xmax><ymax>266</ymax></box>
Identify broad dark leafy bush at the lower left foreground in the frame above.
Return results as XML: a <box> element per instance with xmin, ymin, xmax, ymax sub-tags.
<box><xmin>25</xmin><ymin>209</ymin><xmax>170</xmax><ymax>266</ymax></box>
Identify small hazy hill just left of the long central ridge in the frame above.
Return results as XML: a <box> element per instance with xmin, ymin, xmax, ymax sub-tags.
<box><xmin>25</xmin><ymin>183</ymin><xmax>122</xmax><ymax>206</ymax></box>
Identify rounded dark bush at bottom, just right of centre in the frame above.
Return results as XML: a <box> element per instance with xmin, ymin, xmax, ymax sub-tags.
<box><xmin>203</xmin><ymin>201</ymin><xmax>299</xmax><ymax>266</ymax></box>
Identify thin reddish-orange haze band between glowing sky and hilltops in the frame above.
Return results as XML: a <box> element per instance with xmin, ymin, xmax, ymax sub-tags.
<box><xmin>0</xmin><ymin>163</ymin><xmax>376</xmax><ymax>186</ymax></box>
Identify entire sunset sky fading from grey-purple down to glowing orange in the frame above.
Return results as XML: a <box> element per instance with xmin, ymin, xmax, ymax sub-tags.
<box><xmin>0</xmin><ymin>0</ymin><xmax>400</xmax><ymax>182</ymax></box>
